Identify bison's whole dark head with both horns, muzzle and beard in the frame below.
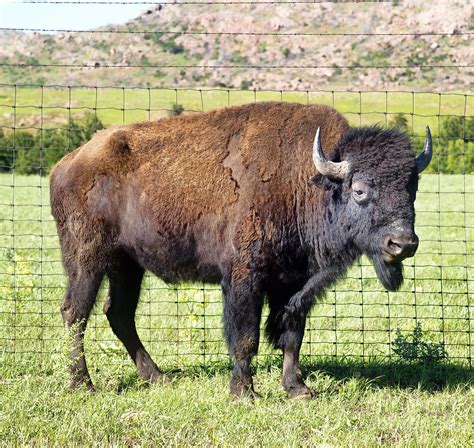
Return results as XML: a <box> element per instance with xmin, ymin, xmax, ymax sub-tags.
<box><xmin>313</xmin><ymin>127</ymin><xmax>432</xmax><ymax>291</ymax></box>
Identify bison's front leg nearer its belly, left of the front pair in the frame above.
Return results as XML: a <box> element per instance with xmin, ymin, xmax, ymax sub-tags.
<box><xmin>222</xmin><ymin>269</ymin><xmax>263</xmax><ymax>397</ymax></box>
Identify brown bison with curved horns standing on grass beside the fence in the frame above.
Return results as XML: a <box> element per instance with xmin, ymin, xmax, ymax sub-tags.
<box><xmin>51</xmin><ymin>102</ymin><xmax>432</xmax><ymax>397</ymax></box>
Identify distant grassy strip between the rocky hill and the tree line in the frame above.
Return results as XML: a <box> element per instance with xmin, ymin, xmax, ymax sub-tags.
<box><xmin>0</xmin><ymin>85</ymin><xmax>474</xmax><ymax>136</ymax></box>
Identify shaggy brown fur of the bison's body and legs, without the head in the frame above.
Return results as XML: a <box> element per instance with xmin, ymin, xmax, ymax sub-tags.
<box><xmin>51</xmin><ymin>103</ymin><xmax>422</xmax><ymax>396</ymax></box>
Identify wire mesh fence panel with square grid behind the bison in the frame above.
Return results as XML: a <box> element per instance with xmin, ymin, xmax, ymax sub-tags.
<box><xmin>0</xmin><ymin>84</ymin><xmax>474</xmax><ymax>371</ymax></box>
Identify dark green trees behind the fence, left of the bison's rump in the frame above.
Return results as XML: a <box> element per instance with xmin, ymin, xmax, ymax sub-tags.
<box><xmin>0</xmin><ymin>114</ymin><xmax>104</xmax><ymax>175</ymax></box>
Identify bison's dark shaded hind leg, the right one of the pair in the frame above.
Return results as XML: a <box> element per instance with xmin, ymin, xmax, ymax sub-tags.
<box><xmin>104</xmin><ymin>253</ymin><xmax>167</xmax><ymax>382</ymax></box>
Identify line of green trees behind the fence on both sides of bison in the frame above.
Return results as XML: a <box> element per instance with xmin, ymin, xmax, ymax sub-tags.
<box><xmin>0</xmin><ymin>110</ymin><xmax>474</xmax><ymax>175</ymax></box>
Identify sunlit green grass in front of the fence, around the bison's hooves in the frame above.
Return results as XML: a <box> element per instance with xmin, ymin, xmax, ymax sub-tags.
<box><xmin>0</xmin><ymin>364</ymin><xmax>474</xmax><ymax>447</ymax></box>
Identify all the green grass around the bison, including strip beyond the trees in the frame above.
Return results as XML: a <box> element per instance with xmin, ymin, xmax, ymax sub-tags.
<box><xmin>0</xmin><ymin>88</ymin><xmax>474</xmax><ymax>446</ymax></box>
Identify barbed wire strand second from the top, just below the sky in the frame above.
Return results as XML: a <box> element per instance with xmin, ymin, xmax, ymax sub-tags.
<box><xmin>0</xmin><ymin>27</ymin><xmax>474</xmax><ymax>36</ymax></box>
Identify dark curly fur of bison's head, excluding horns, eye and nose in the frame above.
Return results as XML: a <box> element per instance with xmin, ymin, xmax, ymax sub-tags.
<box><xmin>311</xmin><ymin>126</ymin><xmax>418</xmax><ymax>291</ymax></box>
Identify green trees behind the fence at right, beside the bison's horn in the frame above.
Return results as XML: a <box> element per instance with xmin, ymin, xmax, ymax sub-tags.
<box><xmin>389</xmin><ymin>113</ymin><xmax>474</xmax><ymax>174</ymax></box>
